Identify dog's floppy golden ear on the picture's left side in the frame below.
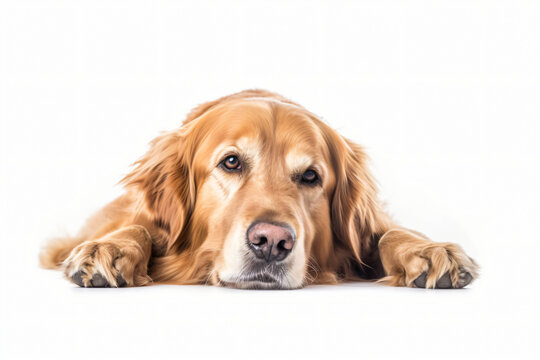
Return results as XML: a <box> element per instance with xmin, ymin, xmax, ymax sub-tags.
<box><xmin>121</xmin><ymin>129</ymin><xmax>195</xmax><ymax>249</ymax></box>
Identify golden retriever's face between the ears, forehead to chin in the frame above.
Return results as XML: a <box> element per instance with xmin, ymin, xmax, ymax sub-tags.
<box><xmin>193</xmin><ymin>99</ymin><xmax>335</xmax><ymax>288</ymax></box>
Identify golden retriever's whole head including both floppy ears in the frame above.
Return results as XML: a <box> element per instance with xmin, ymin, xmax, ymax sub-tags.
<box><xmin>125</xmin><ymin>91</ymin><xmax>387</xmax><ymax>288</ymax></box>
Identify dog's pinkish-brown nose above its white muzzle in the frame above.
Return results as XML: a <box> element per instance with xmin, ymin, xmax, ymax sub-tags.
<box><xmin>247</xmin><ymin>222</ymin><xmax>294</xmax><ymax>262</ymax></box>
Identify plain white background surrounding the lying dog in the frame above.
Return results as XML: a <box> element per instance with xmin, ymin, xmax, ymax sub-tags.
<box><xmin>0</xmin><ymin>0</ymin><xmax>540</xmax><ymax>360</ymax></box>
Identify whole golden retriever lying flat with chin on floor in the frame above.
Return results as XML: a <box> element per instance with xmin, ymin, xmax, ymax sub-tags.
<box><xmin>40</xmin><ymin>90</ymin><xmax>478</xmax><ymax>289</ymax></box>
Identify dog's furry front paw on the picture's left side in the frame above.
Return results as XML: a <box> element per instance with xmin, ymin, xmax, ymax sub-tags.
<box><xmin>63</xmin><ymin>225</ymin><xmax>152</xmax><ymax>287</ymax></box>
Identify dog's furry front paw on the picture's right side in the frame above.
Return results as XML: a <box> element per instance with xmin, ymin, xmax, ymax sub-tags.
<box><xmin>379</xmin><ymin>229</ymin><xmax>478</xmax><ymax>288</ymax></box>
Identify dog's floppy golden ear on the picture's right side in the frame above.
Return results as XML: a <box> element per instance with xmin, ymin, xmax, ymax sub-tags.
<box><xmin>330</xmin><ymin>133</ymin><xmax>390</xmax><ymax>264</ymax></box>
